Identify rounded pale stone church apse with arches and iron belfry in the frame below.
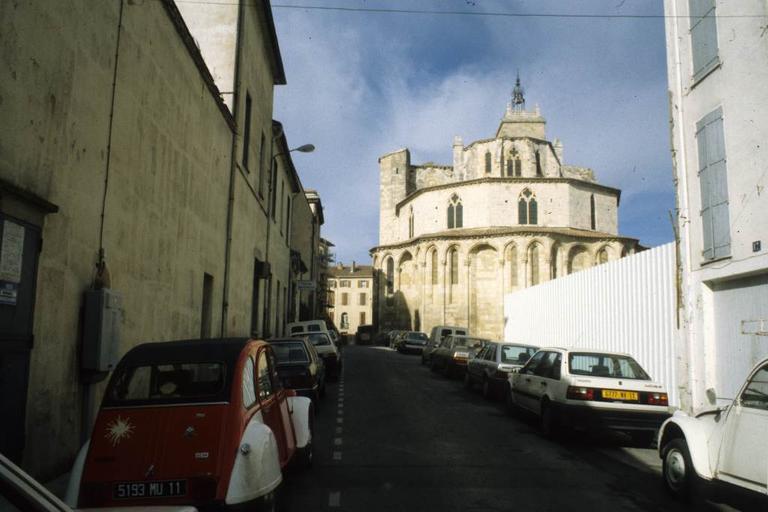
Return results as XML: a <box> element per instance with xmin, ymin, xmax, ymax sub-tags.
<box><xmin>371</xmin><ymin>79</ymin><xmax>639</xmax><ymax>338</ymax></box>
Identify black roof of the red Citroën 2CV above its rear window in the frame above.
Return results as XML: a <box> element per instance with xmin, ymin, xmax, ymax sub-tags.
<box><xmin>119</xmin><ymin>338</ymin><xmax>256</xmax><ymax>366</ymax></box>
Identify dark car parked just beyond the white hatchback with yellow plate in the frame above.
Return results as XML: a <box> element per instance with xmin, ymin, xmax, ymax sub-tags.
<box><xmin>464</xmin><ymin>341</ymin><xmax>539</xmax><ymax>398</ymax></box>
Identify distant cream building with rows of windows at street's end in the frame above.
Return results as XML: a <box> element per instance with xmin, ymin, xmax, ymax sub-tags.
<box><xmin>328</xmin><ymin>261</ymin><xmax>374</xmax><ymax>334</ymax></box>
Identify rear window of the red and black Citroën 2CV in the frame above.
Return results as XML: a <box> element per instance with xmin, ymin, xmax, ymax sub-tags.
<box><xmin>109</xmin><ymin>362</ymin><xmax>225</xmax><ymax>403</ymax></box>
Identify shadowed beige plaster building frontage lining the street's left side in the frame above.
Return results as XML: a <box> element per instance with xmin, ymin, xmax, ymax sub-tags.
<box><xmin>0</xmin><ymin>0</ymin><xmax>319</xmax><ymax>479</ymax></box>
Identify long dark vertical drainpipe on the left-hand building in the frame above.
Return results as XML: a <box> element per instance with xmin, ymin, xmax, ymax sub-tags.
<box><xmin>219</xmin><ymin>2</ymin><xmax>243</xmax><ymax>338</ymax></box>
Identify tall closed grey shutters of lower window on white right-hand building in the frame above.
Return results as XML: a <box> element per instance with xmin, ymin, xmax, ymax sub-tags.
<box><xmin>696</xmin><ymin>108</ymin><xmax>731</xmax><ymax>261</ymax></box>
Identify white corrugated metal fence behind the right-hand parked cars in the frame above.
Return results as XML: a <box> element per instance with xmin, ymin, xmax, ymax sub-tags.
<box><xmin>504</xmin><ymin>243</ymin><xmax>679</xmax><ymax>405</ymax></box>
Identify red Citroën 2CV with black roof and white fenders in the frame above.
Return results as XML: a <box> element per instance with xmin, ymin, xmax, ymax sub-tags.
<box><xmin>67</xmin><ymin>339</ymin><xmax>313</xmax><ymax>508</ymax></box>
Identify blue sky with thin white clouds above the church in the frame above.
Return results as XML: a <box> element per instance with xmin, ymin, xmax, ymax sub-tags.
<box><xmin>272</xmin><ymin>0</ymin><xmax>674</xmax><ymax>264</ymax></box>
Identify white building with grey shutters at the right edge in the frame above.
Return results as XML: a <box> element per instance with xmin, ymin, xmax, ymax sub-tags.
<box><xmin>664</xmin><ymin>0</ymin><xmax>768</xmax><ymax>411</ymax></box>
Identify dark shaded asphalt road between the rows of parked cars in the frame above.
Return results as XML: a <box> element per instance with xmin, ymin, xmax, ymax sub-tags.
<box><xmin>281</xmin><ymin>346</ymin><xmax>724</xmax><ymax>512</ymax></box>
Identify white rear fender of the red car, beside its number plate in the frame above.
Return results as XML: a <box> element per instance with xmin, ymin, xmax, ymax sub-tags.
<box><xmin>224</xmin><ymin>412</ymin><xmax>283</xmax><ymax>505</ymax></box>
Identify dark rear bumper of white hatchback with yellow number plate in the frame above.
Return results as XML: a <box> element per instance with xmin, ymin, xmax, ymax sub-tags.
<box><xmin>555</xmin><ymin>404</ymin><xmax>670</xmax><ymax>431</ymax></box>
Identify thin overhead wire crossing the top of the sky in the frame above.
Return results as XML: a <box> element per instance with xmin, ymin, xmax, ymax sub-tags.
<box><xmin>171</xmin><ymin>0</ymin><xmax>768</xmax><ymax>19</ymax></box>
